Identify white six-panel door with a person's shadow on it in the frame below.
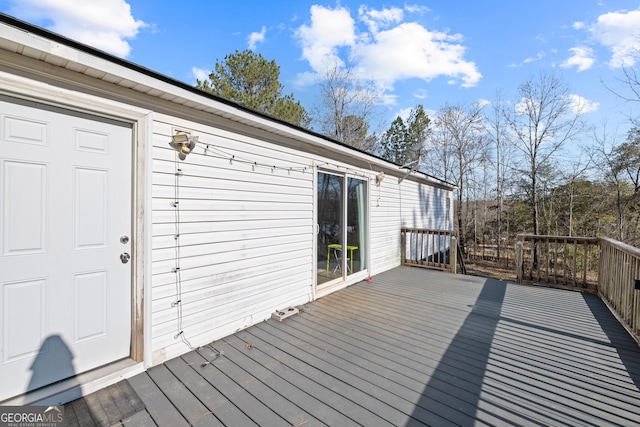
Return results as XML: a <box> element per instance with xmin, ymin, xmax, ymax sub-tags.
<box><xmin>0</xmin><ymin>97</ymin><xmax>132</xmax><ymax>401</ymax></box>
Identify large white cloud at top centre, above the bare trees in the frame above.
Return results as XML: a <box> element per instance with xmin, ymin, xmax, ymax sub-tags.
<box><xmin>296</xmin><ymin>5</ymin><xmax>482</xmax><ymax>98</ymax></box>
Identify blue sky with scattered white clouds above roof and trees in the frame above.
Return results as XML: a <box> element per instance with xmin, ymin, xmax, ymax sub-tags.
<box><xmin>0</xmin><ymin>0</ymin><xmax>640</xmax><ymax>140</ymax></box>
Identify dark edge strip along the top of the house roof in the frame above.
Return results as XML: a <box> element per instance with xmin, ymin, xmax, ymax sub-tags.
<box><xmin>0</xmin><ymin>12</ymin><xmax>456</xmax><ymax>188</ymax></box>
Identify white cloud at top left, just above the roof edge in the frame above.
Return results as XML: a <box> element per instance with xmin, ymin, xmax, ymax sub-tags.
<box><xmin>5</xmin><ymin>0</ymin><xmax>148</xmax><ymax>57</ymax></box>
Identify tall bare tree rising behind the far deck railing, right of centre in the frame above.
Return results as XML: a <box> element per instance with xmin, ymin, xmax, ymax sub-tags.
<box><xmin>505</xmin><ymin>72</ymin><xmax>586</xmax><ymax>264</ymax></box>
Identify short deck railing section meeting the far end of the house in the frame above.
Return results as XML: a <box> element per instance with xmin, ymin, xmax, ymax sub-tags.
<box><xmin>401</xmin><ymin>228</ymin><xmax>457</xmax><ymax>273</ymax></box>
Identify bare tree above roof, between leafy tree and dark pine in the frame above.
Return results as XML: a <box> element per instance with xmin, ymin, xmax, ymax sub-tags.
<box><xmin>313</xmin><ymin>63</ymin><xmax>379</xmax><ymax>151</ymax></box>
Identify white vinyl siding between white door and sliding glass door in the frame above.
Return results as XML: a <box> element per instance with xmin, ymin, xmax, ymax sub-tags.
<box><xmin>152</xmin><ymin>122</ymin><xmax>314</xmax><ymax>362</ymax></box>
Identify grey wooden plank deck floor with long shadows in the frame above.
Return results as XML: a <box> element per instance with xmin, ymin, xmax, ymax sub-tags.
<box><xmin>65</xmin><ymin>267</ymin><xmax>640</xmax><ymax>427</ymax></box>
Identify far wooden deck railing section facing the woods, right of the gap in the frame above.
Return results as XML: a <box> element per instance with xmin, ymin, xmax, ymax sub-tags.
<box><xmin>516</xmin><ymin>234</ymin><xmax>600</xmax><ymax>291</ymax></box>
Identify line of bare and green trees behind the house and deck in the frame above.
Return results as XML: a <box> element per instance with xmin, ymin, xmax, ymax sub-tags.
<box><xmin>197</xmin><ymin>50</ymin><xmax>640</xmax><ymax>250</ymax></box>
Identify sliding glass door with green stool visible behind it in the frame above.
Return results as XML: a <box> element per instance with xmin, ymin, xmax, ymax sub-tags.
<box><xmin>317</xmin><ymin>172</ymin><xmax>367</xmax><ymax>285</ymax></box>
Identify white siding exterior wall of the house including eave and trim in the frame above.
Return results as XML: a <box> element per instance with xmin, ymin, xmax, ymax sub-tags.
<box><xmin>0</xmin><ymin>16</ymin><xmax>452</xmax><ymax>402</ymax></box>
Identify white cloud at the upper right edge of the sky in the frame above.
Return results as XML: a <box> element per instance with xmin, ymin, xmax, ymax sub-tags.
<box><xmin>588</xmin><ymin>9</ymin><xmax>640</xmax><ymax>68</ymax></box>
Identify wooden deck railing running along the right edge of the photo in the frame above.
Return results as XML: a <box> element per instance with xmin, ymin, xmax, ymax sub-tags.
<box><xmin>598</xmin><ymin>237</ymin><xmax>640</xmax><ymax>336</ymax></box>
